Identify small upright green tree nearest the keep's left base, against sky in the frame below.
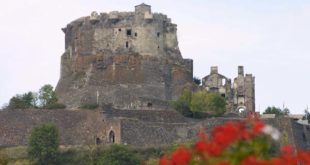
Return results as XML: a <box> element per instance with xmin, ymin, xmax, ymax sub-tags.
<box><xmin>39</xmin><ymin>84</ymin><xmax>58</xmax><ymax>108</ymax></box>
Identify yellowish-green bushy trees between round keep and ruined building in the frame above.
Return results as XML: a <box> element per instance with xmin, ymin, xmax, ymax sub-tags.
<box><xmin>172</xmin><ymin>90</ymin><xmax>226</xmax><ymax>118</ymax></box>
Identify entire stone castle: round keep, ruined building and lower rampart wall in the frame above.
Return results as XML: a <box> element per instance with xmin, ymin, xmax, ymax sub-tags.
<box><xmin>0</xmin><ymin>4</ymin><xmax>310</xmax><ymax>149</ymax></box>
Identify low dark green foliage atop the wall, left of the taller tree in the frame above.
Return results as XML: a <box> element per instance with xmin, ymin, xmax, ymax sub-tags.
<box><xmin>8</xmin><ymin>92</ymin><xmax>36</xmax><ymax>109</ymax></box>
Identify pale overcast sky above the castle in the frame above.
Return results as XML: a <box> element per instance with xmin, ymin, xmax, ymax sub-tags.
<box><xmin>0</xmin><ymin>0</ymin><xmax>310</xmax><ymax>113</ymax></box>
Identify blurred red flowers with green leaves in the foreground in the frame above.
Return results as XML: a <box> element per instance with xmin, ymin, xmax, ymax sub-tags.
<box><xmin>159</xmin><ymin>119</ymin><xmax>310</xmax><ymax>165</ymax></box>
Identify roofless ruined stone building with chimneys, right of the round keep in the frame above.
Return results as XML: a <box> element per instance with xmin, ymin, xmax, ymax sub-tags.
<box><xmin>202</xmin><ymin>66</ymin><xmax>255</xmax><ymax>113</ymax></box>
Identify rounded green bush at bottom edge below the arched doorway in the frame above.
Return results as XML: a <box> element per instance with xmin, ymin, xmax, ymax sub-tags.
<box><xmin>97</xmin><ymin>144</ymin><xmax>141</xmax><ymax>165</ymax></box>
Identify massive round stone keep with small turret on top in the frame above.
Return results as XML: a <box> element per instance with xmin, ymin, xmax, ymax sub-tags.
<box><xmin>56</xmin><ymin>4</ymin><xmax>193</xmax><ymax>109</ymax></box>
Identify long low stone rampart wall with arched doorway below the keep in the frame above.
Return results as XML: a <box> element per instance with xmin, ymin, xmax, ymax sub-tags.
<box><xmin>0</xmin><ymin>109</ymin><xmax>310</xmax><ymax>149</ymax></box>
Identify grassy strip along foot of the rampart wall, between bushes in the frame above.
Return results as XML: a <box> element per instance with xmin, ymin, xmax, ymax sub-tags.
<box><xmin>0</xmin><ymin>144</ymin><xmax>178</xmax><ymax>165</ymax></box>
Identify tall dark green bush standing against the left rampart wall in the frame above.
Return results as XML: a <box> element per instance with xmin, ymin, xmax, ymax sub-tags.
<box><xmin>27</xmin><ymin>124</ymin><xmax>59</xmax><ymax>165</ymax></box>
